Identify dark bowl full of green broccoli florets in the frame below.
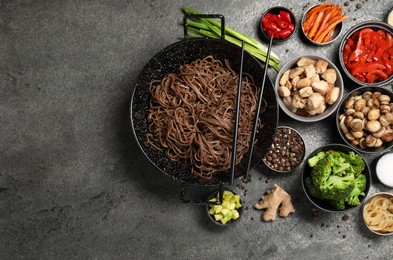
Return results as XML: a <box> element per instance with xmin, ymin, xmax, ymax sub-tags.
<box><xmin>302</xmin><ymin>144</ymin><xmax>371</xmax><ymax>212</ymax></box>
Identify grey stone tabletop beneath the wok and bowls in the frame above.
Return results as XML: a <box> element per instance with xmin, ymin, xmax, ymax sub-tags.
<box><xmin>0</xmin><ymin>0</ymin><xmax>393</xmax><ymax>259</ymax></box>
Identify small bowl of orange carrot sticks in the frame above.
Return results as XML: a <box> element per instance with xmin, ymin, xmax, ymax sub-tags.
<box><xmin>301</xmin><ymin>3</ymin><xmax>349</xmax><ymax>46</ymax></box>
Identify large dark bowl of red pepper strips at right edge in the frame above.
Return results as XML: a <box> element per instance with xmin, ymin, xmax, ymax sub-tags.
<box><xmin>339</xmin><ymin>21</ymin><xmax>393</xmax><ymax>86</ymax></box>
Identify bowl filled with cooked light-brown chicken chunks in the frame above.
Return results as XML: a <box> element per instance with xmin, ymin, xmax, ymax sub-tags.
<box><xmin>275</xmin><ymin>55</ymin><xmax>344</xmax><ymax>122</ymax></box>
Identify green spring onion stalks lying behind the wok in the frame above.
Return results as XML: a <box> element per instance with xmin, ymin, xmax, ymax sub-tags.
<box><xmin>183</xmin><ymin>7</ymin><xmax>280</xmax><ymax>71</ymax></box>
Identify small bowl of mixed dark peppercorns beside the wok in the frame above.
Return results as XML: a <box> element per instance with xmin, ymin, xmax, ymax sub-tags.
<box><xmin>262</xmin><ymin>126</ymin><xmax>306</xmax><ymax>173</ymax></box>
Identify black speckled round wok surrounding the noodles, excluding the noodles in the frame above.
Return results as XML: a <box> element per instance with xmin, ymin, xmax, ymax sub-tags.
<box><xmin>131</xmin><ymin>18</ymin><xmax>278</xmax><ymax>185</ymax></box>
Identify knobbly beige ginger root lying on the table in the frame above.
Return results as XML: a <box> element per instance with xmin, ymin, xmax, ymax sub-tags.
<box><xmin>255</xmin><ymin>184</ymin><xmax>295</xmax><ymax>221</ymax></box>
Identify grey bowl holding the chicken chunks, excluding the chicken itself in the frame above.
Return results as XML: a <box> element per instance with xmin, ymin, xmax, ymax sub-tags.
<box><xmin>274</xmin><ymin>55</ymin><xmax>344</xmax><ymax>123</ymax></box>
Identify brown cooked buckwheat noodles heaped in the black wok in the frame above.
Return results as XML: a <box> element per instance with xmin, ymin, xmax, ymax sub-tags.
<box><xmin>147</xmin><ymin>56</ymin><xmax>266</xmax><ymax>179</ymax></box>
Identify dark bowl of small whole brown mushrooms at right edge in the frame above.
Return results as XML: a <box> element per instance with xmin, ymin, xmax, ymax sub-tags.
<box><xmin>336</xmin><ymin>86</ymin><xmax>393</xmax><ymax>153</ymax></box>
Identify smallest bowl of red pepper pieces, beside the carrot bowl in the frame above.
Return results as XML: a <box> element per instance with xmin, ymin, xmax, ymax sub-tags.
<box><xmin>260</xmin><ymin>6</ymin><xmax>296</xmax><ymax>43</ymax></box>
